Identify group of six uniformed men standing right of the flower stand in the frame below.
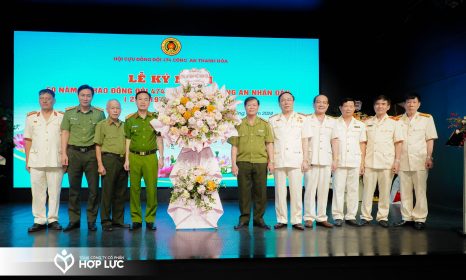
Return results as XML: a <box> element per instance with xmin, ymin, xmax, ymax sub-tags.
<box><xmin>229</xmin><ymin>92</ymin><xmax>437</xmax><ymax>230</ymax></box>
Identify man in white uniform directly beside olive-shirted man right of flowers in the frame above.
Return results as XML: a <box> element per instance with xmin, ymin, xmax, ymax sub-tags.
<box><xmin>269</xmin><ymin>91</ymin><xmax>311</xmax><ymax>230</ymax></box>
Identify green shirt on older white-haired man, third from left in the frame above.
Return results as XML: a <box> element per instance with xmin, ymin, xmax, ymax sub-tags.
<box><xmin>94</xmin><ymin>118</ymin><xmax>126</xmax><ymax>155</ymax></box>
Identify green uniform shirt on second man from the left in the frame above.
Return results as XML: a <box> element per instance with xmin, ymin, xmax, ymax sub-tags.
<box><xmin>61</xmin><ymin>106</ymin><xmax>105</xmax><ymax>147</ymax></box>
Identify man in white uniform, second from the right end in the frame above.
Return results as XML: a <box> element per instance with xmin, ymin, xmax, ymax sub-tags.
<box><xmin>361</xmin><ymin>95</ymin><xmax>403</xmax><ymax>227</ymax></box>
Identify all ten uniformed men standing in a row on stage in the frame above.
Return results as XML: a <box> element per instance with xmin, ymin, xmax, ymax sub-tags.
<box><xmin>24</xmin><ymin>85</ymin><xmax>437</xmax><ymax>232</ymax></box>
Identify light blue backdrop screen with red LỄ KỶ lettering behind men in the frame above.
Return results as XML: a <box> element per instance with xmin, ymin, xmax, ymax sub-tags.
<box><xmin>14</xmin><ymin>31</ymin><xmax>319</xmax><ymax>188</ymax></box>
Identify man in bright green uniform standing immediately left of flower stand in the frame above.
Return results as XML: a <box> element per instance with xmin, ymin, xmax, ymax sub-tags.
<box><xmin>125</xmin><ymin>91</ymin><xmax>163</xmax><ymax>230</ymax></box>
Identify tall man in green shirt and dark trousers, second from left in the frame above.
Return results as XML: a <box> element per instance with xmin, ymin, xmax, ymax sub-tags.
<box><xmin>61</xmin><ymin>85</ymin><xmax>105</xmax><ymax>232</ymax></box>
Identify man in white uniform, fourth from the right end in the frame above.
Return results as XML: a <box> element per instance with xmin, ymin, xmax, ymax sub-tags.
<box><xmin>304</xmin><ymin>94</ymin><xmax>338</xmax><ymax>228</ymax></box>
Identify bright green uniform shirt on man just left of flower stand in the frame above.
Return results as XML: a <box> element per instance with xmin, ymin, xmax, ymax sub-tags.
<box><xmin>125</xmin><ymin>112</ymin><xmax>160</xmax><ymax>152</ymax></box>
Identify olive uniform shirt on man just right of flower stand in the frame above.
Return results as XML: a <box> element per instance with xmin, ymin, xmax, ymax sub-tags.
<box><xmin>228</xmin><ymin>117</ymin><xmax>273</xmax><ymax>163</ymax></box>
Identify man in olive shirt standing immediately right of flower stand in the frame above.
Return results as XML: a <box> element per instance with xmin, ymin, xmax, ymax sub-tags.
<box><xmin>228</xmin><ymin>97</ymin><xmax>274</xmax><ymax>230</ymax></box>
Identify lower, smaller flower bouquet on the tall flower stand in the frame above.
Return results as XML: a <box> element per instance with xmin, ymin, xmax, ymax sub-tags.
<box><xmin>170</xmin><ymin>166</ymin><xmax>221</xmax><ymax>211</ymax></box>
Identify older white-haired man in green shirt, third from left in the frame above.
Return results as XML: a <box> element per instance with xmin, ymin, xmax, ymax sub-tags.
<box><xmin>94</xmin><ymin>99</ymin><xmax>129</xmax><ymax>231</ymax></box>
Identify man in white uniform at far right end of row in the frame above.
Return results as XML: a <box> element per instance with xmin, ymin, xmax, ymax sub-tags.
<box><xmin>396</xmin><ymin>94</ymin><xmax>438</xmax><ymax>230</ymax></box>
